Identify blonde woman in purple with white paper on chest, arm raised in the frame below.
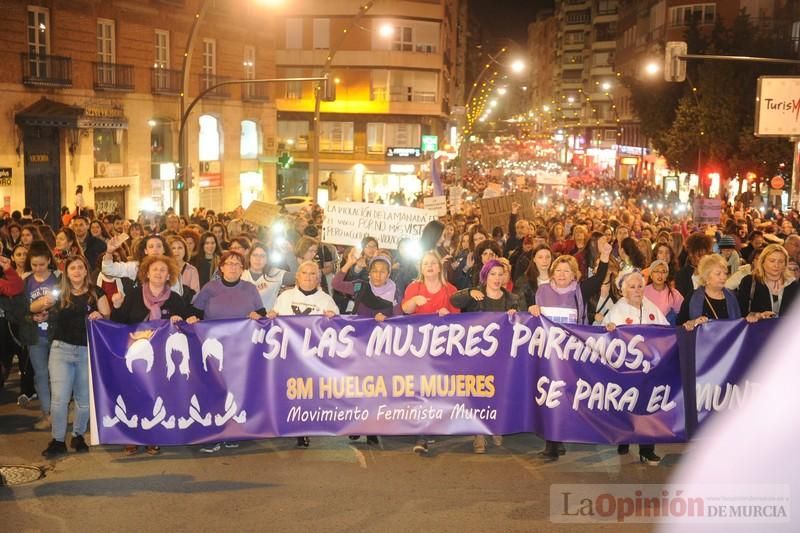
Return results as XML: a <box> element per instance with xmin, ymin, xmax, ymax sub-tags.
<box><xmin>529</xmin><ymin>237</ymin><xmax>612</xmax><ymax>461</ymax></box>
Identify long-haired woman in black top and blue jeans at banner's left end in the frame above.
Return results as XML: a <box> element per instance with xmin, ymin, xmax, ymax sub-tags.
<box><xmin>42</xmin><ymin>255</ymin><xmax>109</xmax><ymax>457</ymax></box>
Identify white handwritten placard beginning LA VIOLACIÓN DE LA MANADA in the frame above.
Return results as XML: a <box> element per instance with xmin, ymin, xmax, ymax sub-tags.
<box><xmin>322</xmin><ymin>202</ymin><xmax>436</xmax><ymax>250</ymax></box>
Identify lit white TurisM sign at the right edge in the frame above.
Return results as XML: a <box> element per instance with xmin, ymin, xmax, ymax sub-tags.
<box><xmin>755</xmin><ymin>76</ymin><xmax>800</xmax><ymax>137</ymax></box>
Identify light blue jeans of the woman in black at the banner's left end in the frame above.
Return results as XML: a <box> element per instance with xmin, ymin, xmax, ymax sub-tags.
<box><xmin>50</xmin><ymin>341</ymin><xmax>89</xmax><ymax>442</ymax></box>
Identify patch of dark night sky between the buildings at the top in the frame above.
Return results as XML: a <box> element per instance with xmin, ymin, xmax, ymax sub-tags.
<box><xmin>469</xmin><ymin>0</ymin><xmax>553</xmax><ymax>43</ymax></box>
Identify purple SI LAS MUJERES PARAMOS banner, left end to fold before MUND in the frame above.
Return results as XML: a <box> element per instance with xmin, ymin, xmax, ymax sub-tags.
<box><xmin>89</xmin><ymin>313</ymin><xmax>686</xmax><ymax>445</ymax></box>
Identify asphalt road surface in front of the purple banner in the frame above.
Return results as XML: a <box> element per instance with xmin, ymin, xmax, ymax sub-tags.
<box><xmin>0</xmin><ymin>370</ymin><xmax>685</xmax><ymax>533</ymax></box>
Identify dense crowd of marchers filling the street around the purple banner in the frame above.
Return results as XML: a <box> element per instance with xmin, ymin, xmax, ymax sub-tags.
<box><xmin>0</xmin><ymin>182</ymin><xmax>800</xmax><ymax>464</ymax></box>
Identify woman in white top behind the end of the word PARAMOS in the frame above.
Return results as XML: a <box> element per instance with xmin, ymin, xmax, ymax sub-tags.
<box><xmin>603</xmin><ymin>270</ymin><xmax>669</xmax><ymax>465</ymax></box>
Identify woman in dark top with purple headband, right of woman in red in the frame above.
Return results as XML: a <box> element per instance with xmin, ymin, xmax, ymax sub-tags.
<box><xmin>450</xmin><ymin>258</ymin><xmax>520</xmax><ymax>453</ymax></box>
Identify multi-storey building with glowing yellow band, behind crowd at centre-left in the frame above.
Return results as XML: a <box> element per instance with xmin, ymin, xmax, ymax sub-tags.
<box><xmin>275</xmin><ymin>0</ymin><xmax>466</xmax><ymax>203</ymax></box>
